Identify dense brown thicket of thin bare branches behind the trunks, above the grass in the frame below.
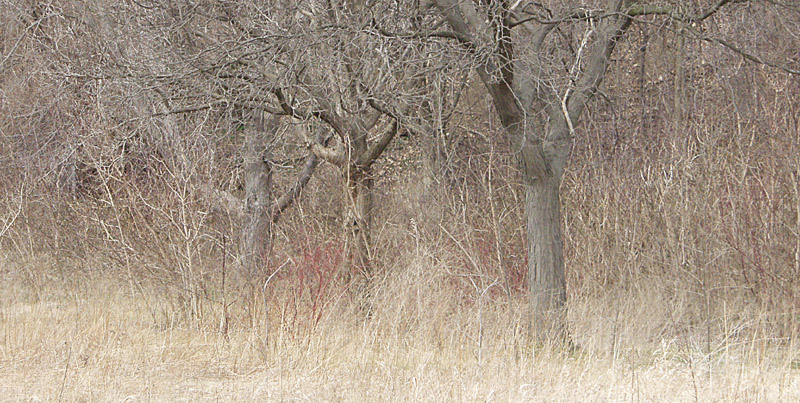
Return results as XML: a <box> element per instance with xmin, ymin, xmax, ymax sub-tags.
<box><xmin>0</xmin><ymin>1</ymin><xmax>800</xmax><ymax>343</ymax></box>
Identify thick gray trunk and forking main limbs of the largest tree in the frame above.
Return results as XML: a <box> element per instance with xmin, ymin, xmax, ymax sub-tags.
<box><xmin>436</xmin><ymin>0</ymin><xmax>631</xmax><ymax>341</ymax></box>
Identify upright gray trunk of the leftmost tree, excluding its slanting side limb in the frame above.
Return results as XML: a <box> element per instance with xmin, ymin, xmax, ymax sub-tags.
<box><xmin>240</xmin><ymin>112</ymin><xmax>273</xmax><ymax>282</ymax></box>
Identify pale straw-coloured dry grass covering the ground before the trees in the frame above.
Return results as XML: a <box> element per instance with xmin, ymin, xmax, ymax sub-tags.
<box><xmin>0</xmin><ymin>250</ymin><xmax>800</xmax><ymax>401</ymax></box>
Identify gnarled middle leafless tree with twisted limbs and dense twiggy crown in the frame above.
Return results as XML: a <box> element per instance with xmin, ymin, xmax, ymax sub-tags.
<box><xmin>115</xmin><ymin>1</ymin><xmax>444</xmax><ymax>284</ymax></box>
